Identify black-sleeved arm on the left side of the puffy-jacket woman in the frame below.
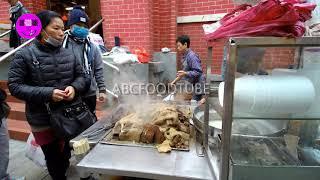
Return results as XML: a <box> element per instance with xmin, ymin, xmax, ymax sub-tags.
<box><xmin>8</xmin><ymin>51</ymin><xmax>54</xmax><ymax>103</ymax></box>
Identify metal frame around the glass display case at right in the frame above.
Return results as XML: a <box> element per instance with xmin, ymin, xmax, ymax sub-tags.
<box><xmin>203</xmin><ymin>37</ymin><xmax>320</xmax><ymax>180</ymax></box>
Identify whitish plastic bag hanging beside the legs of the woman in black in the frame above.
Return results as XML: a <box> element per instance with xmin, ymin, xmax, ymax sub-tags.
<box><xmin>25</xmin><ymin>133</ymin><xmax>47</xmax><ymax>169</ymax></box>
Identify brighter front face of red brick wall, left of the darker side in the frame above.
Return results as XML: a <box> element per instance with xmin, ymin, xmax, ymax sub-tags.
<box><xmin>100</xmin><ymin>0</ymin><xmax>153</xmax><ymax>53</ymax></box>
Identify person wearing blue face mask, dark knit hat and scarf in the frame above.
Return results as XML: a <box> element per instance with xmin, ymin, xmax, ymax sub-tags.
<box><xmin>63</xmin><ymin>6</ymin><xmax>106</xmax><ymax>116</ymax></box>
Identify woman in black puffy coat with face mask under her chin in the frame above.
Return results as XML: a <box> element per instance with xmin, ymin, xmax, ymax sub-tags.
<box><xmin>8</xmin><ymin>11</ymin><xmax>87</xmax><ymax>180</ymax></box>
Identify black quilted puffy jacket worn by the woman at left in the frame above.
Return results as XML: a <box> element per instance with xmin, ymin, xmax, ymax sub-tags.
<box><xmin>8</xmin><ymin>40</ymin><xmax>90</xmax><ymax>127</ymax></box>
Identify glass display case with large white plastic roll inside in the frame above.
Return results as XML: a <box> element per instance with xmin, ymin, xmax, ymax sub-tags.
<box><xmin>203</xmin><ymin>37</ymin><xmax>320</xmax><ymax>180</ymax></box>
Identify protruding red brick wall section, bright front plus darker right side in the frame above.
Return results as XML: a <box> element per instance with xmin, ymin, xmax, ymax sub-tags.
<box><xmin>100</xmin><ymin>0</ymin><xmax>177</xmax><ymax>54</ymax></box>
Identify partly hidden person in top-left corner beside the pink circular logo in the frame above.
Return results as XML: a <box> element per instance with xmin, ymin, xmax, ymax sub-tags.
<box><xmin>8</xmin><ymin>0</ymin><xmax>28</xmax><ymax>48</ymax></box>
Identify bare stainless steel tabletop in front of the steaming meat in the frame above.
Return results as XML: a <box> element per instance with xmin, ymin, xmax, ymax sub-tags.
<box><xmin>77</xmin><ymin>131</ymin><xmax>215</xmax><ymax>180</ymax></box>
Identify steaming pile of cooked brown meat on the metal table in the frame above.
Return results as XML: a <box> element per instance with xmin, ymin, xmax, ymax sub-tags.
<box><xmin>113</xmin><ymin>104</ymin><xmax>191</xmax><ymax>152</ymax></box>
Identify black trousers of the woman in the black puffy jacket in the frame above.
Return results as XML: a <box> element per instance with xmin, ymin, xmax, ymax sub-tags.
<box><xmin>41</xmin><ymin>140</ymin><xmax>71</xmax><ymax>180</ymax></box>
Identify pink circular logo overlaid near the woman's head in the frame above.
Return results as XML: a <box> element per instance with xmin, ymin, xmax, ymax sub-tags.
<box><xmin>16</xmin><ymin>14</ymin><xmax>42</xmax><ymax>39</ymax></box>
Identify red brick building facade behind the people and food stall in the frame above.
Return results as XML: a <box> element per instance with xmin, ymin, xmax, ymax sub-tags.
<box><xmin>0</xmin><ymin>0</ymin><xmax>294</xmax><ymax>74</ymax></box>
